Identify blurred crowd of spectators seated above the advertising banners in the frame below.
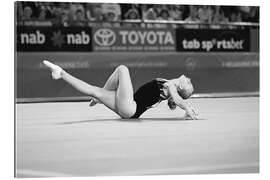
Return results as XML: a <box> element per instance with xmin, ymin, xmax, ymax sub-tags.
<box><xmin>16</xmin><ymin>2</ymin><xmax>259</xmax><ymax>28</ymax></box>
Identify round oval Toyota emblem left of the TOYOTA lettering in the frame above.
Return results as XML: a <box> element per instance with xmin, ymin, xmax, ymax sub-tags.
<box><xmin>94</xmin><ymin>29</ymin><xmax>116</xmax><ymax>46</ymax></box>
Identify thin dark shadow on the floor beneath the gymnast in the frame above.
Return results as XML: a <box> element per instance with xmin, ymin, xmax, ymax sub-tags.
<box><xmin>57</xmin><ymin>117</ymin><xmax>205</xmax><ymax>125</ymax></box>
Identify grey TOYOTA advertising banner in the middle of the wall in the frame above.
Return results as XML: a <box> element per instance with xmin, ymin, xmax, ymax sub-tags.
<box><xmin>93</xmin><ymin>28</ymin><xmax>175</xmax><ymax>52</ymax></box>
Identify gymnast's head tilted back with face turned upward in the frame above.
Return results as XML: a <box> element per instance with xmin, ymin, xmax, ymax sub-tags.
<box><xmin>177</xmin><ymin>75</ymin><xmax>194</xmax><ymax>99</ymax></box>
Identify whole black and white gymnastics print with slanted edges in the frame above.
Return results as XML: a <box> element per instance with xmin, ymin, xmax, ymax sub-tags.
<box><xmin>14</xmin><ymin>0</ymin><xmax>261</xmax><ymax>178</ymax></box>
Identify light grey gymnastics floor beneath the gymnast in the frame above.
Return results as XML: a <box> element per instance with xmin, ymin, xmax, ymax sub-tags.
<box><xmin>16</xmin><ymin>97</ymin><xmax>259</xmax><ymax>177</ymax></box>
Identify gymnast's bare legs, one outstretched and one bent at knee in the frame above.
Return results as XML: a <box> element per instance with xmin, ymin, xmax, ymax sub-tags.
<box><xmin>43</xmin><ymin>61</ymin><xmax>136</xmax><ymax>118</ymax></box>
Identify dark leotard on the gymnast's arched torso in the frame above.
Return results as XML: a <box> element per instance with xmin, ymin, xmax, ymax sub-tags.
<box><xmin>130</xmin><ymin>78</ymin><xmax>167</xmax><ymax>118</ymax></box>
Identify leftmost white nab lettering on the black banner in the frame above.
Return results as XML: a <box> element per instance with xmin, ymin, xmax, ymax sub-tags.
<box><xmin>20</xmin><ymin>30</ymin><xmax>46</xmax><ymax>44</ymax></box>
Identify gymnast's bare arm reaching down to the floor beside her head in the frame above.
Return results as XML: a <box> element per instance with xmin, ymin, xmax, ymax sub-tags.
<box><xmin>167</xmin><ymin>84</ymin><xmax>197</xmax><ymax>119</ymax></box>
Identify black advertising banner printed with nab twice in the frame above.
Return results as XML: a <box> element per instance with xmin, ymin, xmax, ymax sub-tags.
<box><xmin>16</xmin><ymin>26</ymin><xmax>92</xmax><ymax>52</ymax></box>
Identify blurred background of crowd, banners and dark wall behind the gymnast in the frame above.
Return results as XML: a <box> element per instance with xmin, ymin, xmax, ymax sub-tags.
<box><xmin>15</xmin><ymin>1</ymin><xmax>259</xmax><ymax>102</ymax></box>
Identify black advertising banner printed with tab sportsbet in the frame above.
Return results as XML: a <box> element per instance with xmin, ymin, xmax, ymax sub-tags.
<box><xmin>176</xmin><ymin>29</ymin><xmax>250</xmax><ymax>52</ymax></box>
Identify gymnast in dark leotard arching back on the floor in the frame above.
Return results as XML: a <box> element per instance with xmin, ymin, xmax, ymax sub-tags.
<box><xmin>43</xmin><ymin>60</ymin><xmax>198</xmax><ymax>119</ymax></box>
